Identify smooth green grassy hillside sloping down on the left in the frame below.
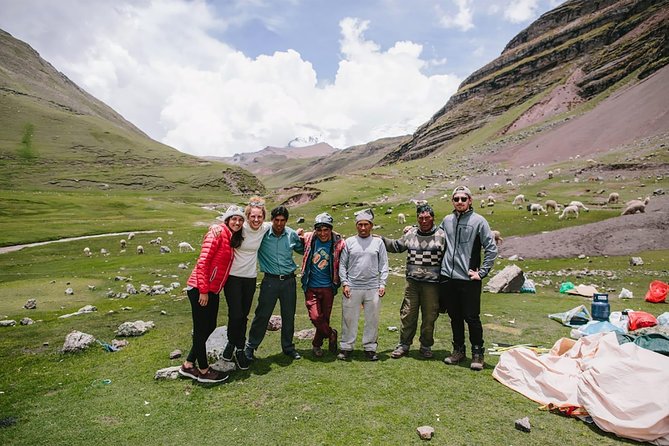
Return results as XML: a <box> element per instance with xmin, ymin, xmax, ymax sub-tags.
<box><xmin>0</xmin><ymin>30</ymin><xmax>264</xmax><ymax>194</ymax></box>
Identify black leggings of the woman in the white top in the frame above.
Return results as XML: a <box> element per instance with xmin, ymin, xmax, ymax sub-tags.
<box><xmin>223</xmin><ymin>276</ymin><xmax>256</xmax><ymax>350</ymax></box>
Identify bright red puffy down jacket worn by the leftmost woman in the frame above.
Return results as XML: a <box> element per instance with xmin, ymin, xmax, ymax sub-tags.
<box><xmin>188</xmin><ymin>225</ymin><xmax>234</xmax><ymax>294</ymax></box>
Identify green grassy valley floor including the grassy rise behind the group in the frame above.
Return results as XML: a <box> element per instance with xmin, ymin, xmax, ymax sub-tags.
<box><xmin>0</xmin><ymin>170</ymin><xmax>669</xmax><ymax>445</ymax></box>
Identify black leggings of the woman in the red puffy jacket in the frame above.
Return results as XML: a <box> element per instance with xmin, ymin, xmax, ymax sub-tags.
<box><xmin>186</xmin><ymin>288</ymin><xmax>220</xmax><ymax>370</ymax></box>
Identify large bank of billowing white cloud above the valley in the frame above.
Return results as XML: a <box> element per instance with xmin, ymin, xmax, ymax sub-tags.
<box><xmin>0</xmin><ymin>0</ymin><xmax>464</xmax><ymax>156</ymax></box>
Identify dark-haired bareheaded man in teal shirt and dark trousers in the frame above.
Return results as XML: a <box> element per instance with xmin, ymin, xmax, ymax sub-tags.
<box><xmin>244</xmin><ymin>206</ymin><xmax>304</xmax><ymax>360</ymax></box>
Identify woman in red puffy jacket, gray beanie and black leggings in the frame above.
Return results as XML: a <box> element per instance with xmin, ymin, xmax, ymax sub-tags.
<box><xmin>179</xmin><ymin>205</ymin><xmax>244</xmax><ymax>383</ymax></box>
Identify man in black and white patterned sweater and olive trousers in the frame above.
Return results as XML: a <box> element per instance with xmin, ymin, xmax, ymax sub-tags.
<box><xmin>382</xmin><ymin>204</ymin><xmax>446</xmax><ymax>359</ymax></box>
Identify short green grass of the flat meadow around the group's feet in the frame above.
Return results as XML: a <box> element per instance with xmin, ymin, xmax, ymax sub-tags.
<box><xmin>0</xmin><ymin>212</ymin><xmax>669</xmax><ymax>445</ymax></box>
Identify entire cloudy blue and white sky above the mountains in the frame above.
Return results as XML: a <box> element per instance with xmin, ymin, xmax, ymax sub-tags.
<box><xmin>0</xmin><ymin>0</ymin><xmax>562</xmax><ymax>156</ymax></box>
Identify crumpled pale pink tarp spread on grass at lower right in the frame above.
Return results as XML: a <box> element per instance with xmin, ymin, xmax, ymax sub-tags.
<box><xmin>492</xmin><ymin>333</ymin><xmax>669</xmax><ymax>445</ymax></box>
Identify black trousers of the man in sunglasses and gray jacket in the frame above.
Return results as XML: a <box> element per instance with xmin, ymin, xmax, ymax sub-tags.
<box><xmin>440</xmin><ymin>276</ymin><xmax>483</xmax><ymax>353</ymax></box>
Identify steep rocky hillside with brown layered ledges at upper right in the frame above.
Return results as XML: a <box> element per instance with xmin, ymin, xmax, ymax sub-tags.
<box><xmin>381</xmin><ymin>0</ymin><xmax>669</xmax><ymax>164</ymax></box>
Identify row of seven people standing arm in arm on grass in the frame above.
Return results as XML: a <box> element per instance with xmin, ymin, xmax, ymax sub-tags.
<box><xmin>179</xmin><ymin>186</ymin><xmax>497</xmax><ymax>383</ymax></box>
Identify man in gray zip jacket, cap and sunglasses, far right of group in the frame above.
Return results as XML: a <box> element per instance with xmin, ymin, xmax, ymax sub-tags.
<box><xmin>439</xmin><ymin>186</ymin><xmax>497</xmax><ymax>370</ymax></box>
